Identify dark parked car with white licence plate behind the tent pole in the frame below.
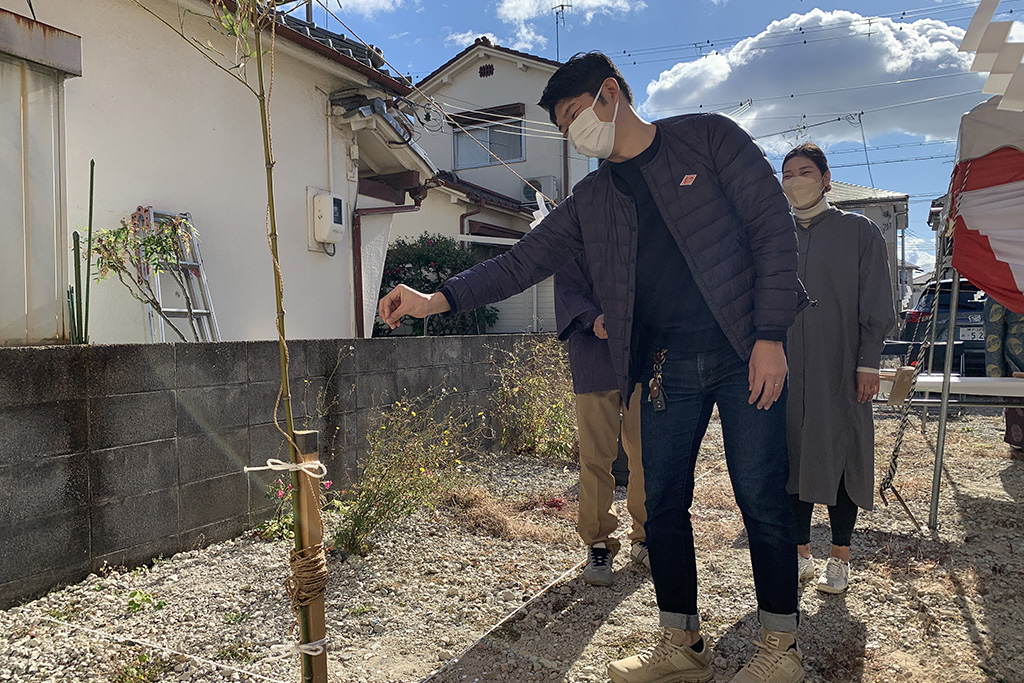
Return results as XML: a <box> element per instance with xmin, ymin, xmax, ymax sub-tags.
<box><xmin>899</xmin><ymin>278</ymin><xmax>987</xmax><ymax>377</ymax></box>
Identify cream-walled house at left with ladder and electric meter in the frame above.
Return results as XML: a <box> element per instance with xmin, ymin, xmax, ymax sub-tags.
<box><xmin>0</xmin><ymin>0</ymin><xmax>436</xmax><ymax>344</ymax></box>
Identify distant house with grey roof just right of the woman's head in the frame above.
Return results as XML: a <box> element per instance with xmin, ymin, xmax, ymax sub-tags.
<box><xmin>825</xmin><ymin>180</ymin><xmax>912</xmax><ymax>312</ymax></box>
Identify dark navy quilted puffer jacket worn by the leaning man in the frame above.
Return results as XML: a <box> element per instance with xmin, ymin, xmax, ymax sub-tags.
<box><xmin>441</xmin><ymin>114</ymin><xmax>807</xmax><ymax>399</ymax></box>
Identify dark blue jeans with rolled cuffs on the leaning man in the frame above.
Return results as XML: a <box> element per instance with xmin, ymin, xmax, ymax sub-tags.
<box><xmin>640</xmin><ymin>347</ymin><xmax>799</xmax><ymax>631</ymax></box>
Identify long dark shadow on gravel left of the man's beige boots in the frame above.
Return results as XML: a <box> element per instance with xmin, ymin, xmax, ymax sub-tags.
<box><xmin>424</xmin><ymin>564</ymin><xmax>650</xmax><ymax>683</ymax></box>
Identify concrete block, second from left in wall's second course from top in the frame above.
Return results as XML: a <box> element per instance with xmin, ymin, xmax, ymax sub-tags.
<box><xmin>88</xmin><ymin>391</ymin><xmax>175</xmax><ymax>451</ymax></box>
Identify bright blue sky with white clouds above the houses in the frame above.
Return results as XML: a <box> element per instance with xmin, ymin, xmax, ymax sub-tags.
<box><xmin>299</xmin><ymin>0</ymin><xmax>1024</xmax><ymax>269</ymax></box>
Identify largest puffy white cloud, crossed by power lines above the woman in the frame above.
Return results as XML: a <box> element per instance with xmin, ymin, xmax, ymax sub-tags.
<box><xmin>642</xmin><ymin>9</ymin><xmax>986</xmax><ymax>144</ymax></box>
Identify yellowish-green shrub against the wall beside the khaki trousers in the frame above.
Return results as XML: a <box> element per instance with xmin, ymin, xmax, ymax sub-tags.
<box><xmin>492</xmin><ymin>336</ymin><xmax>580</xmax><ymax>460</ymax></box>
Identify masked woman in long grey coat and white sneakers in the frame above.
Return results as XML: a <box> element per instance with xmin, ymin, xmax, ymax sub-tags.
<box><xmin>782</xmin><ymin>142</ymin><xmax>896</xmax><ymax>593</ymax></box>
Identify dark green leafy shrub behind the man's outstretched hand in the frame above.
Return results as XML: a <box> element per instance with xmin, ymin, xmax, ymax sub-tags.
<box><xmin>374</xmin><ymin>232</ymin><xmax>498</xmax><ymax>337</ymax></box>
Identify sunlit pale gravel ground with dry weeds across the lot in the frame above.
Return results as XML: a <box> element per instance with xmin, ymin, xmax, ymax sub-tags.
<box><xmin>0</xmin><ymin>412</ymin><xmax>1024</xmax><ymax>683</ymax></box>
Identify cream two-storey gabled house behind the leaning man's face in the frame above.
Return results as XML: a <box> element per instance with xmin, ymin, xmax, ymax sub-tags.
<box><xmin>392</xmin><ymin>37</ymin><xmax>590</xmax><ymax>332</ymax></box>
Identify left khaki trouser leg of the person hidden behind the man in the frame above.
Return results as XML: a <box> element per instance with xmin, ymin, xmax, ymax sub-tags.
<box><xmin>575</xmin><ymin>391</ymin><xmax>622</xmax><ymax>553</ymax></box>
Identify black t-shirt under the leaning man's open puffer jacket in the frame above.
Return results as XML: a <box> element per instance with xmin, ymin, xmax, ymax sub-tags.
<box><xmin>610</xmin><ymin>130</ymin><xmax>729</xmax><ymax>357</ymax></box>
